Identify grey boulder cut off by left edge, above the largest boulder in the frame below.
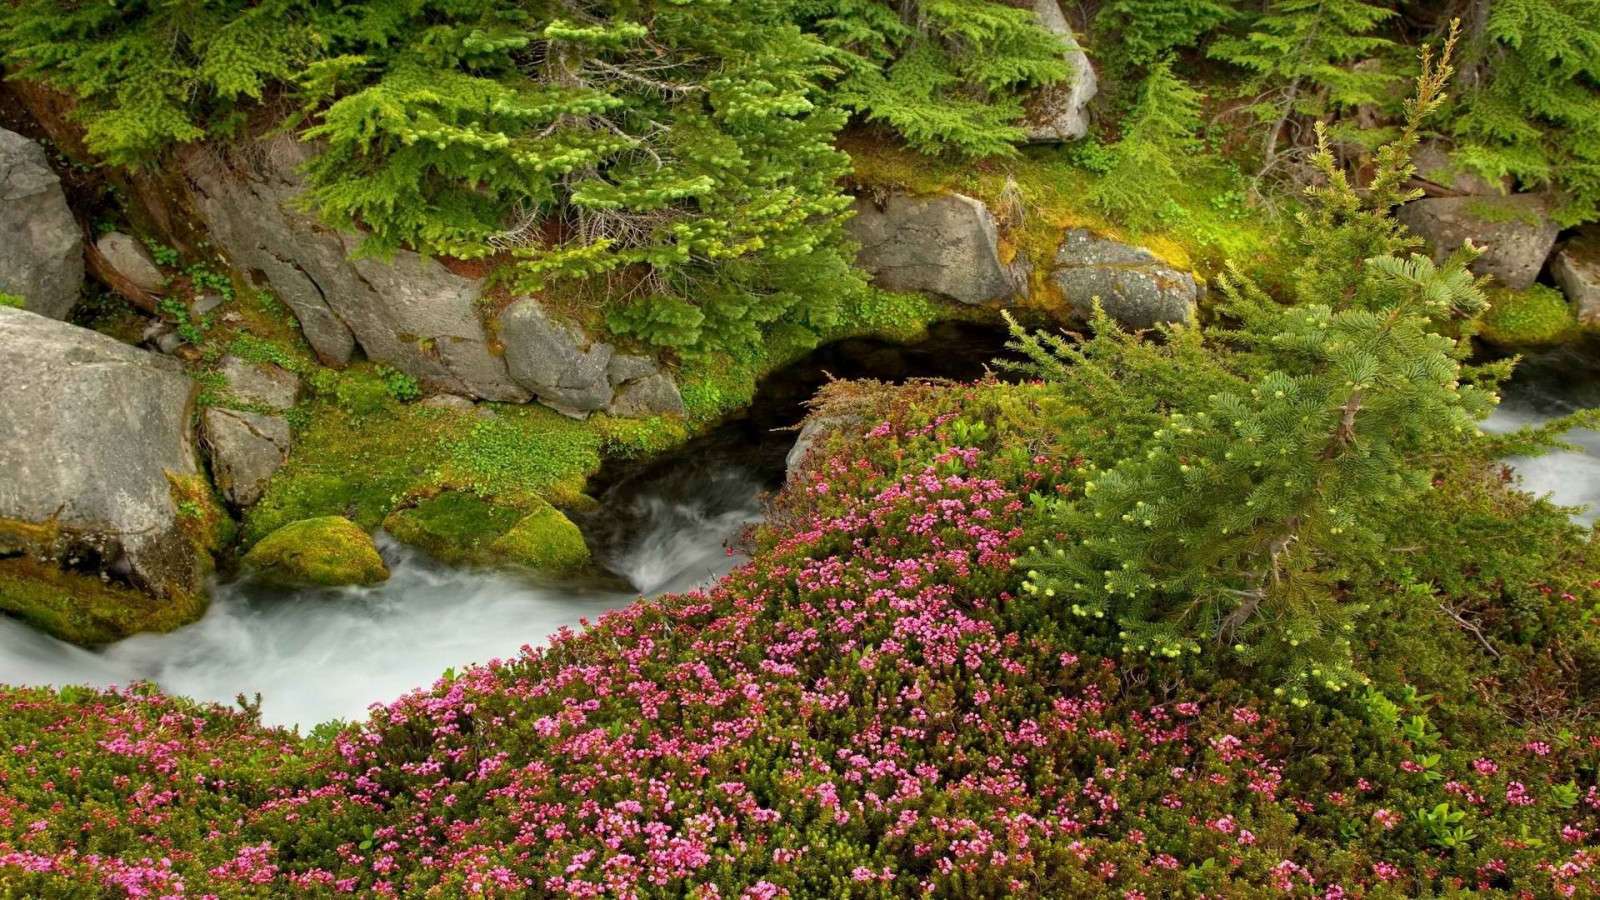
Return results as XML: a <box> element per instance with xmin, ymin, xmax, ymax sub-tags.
<box><xmin>0</xmin><ymin>128</ymin><xmax>83</xmax><ymax>319</ymax></box>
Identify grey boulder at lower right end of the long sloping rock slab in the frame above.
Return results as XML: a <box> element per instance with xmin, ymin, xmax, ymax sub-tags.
<box><xmin>499</xmin><ymin>296</ymin><xmax>614</xmax><ymax>418</ymax></box>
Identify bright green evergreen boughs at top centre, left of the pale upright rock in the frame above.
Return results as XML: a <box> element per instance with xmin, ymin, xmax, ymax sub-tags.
<box><xmin>795</xmin><ymin>0</ymin><xmax>1070</xmax><ymax>157</ymax></box>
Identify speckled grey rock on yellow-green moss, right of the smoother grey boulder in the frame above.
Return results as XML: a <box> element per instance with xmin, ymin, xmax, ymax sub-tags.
<box><xmin>1050</xmin><ymin>229</ymin><xmax>1200</xmax><ymax>328</ymax></box>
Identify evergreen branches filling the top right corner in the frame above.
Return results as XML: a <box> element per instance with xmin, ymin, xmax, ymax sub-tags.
<box><xmin>1450</xmin><ymin>0</ymin><xmax>1600</xmax><ymax>224</ymax></box>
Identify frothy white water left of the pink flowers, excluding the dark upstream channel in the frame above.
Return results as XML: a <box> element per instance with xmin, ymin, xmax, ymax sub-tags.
<box><xmin>0</xmin><ymin>458</ymin><xmax>762</xmax><ymax>729</ymax></box>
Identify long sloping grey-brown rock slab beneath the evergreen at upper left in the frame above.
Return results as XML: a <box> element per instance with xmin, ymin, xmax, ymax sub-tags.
<box><xmin>184</xmin><ymin>138</ymin><xmax>528</xmax><ymax>402</ymax></box>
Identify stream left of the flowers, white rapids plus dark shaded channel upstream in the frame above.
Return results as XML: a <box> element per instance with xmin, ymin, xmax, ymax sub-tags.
<box><xmin>0</xmin><ymin>323</ymin><xmax>1005</xmax><ymax>729</ymax></box>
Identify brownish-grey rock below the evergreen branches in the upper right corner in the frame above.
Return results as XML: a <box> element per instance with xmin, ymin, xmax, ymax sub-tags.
<box><xmin>1395</xmin><ymin>194</ymin><xmax>1560</xmax><ymax>290</ymax></box>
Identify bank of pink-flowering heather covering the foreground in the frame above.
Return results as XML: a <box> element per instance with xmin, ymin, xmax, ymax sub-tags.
<box><xmin>0</xmin><ymin>384</ymin><xmax>1600</xmax><ymax>900</ymax></box>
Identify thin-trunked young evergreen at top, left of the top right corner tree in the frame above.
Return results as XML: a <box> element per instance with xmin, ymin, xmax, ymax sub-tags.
<box><xmin>1210</xmin><ymin>0</ymin><xmax>1395</xmax><ymax>175</ymax></box>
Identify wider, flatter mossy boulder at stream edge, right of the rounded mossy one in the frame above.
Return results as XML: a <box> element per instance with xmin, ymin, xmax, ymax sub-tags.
<box><xmin>384</xmin><ymin>492</ymin><xmax>589</xmax><ymax>573</ymax></box>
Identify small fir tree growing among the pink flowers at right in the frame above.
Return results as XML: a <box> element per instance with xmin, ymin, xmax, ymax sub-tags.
<box><xmin>1016</xmin><ymin>31</ymin><xmax>1493</xmax><ymax>701</ymax></box>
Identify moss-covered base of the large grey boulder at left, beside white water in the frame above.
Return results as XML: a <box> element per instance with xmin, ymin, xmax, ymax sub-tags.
<box><xmin>0</xmin><ymin>557</ymin><xmax>205</xmax><ymax>647</ymax></box>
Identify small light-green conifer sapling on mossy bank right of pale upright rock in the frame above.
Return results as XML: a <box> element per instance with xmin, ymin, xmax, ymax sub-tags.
<box><xmin>1090</xmin><ymin>59</ymin><xmax>1200</xmax><ymax>227</ymax></box>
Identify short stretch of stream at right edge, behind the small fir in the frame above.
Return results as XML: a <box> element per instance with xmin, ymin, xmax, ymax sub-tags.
<box><xmin>1483</xmin><ymin>341</ymin><xmax>1600</xmax><ymax>525</ymax></box>
